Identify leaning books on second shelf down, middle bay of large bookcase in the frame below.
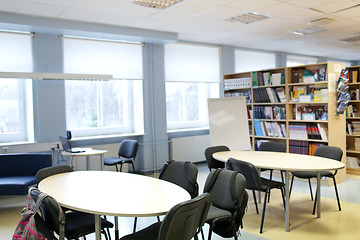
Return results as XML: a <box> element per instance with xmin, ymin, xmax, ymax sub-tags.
<box><xmin>253</xmin><ymin>87</ymin><xmax>286</xmax><ymax>103</ymax></box>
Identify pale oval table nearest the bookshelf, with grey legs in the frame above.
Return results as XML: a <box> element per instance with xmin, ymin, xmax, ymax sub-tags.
<box><xmin>213</xmin><ymin>151</ymin><xmax>345</xmax><ymax>232</ymax></box>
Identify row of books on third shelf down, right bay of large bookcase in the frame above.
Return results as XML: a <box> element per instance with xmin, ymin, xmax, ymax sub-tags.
<box><xmin>293</xmin><ymin>105</ymin><xmax>328</xmax><ymax>121</ymax></box>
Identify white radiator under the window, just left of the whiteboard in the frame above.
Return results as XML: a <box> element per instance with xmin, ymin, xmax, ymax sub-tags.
<box><xmin>170</xmin><ymin>135</ymin><xmax>210</xmax><ymax>162</ymax></box>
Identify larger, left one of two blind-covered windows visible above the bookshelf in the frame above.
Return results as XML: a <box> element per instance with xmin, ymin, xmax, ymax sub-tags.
<box><xmin>235</xmin><ymin>50</ymin><xmax>276</xmax><ymax>72</ymax></box>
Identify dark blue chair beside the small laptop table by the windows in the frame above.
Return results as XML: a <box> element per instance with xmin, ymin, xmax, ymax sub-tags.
<box><xmin>104</xmin><ymin>139</ymin><xmax>139</xmax><ymax>173</ymax></box>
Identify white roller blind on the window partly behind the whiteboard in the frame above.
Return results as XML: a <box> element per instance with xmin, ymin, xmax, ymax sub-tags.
<box><xmin>165</xmin><ymin>43</ymin><xmax>220</xmax><ymax>83</ymax></box>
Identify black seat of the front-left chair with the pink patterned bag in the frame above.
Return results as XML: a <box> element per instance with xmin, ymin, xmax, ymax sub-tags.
<box><xmin>65</xmin><ymin>211</ymin><xmax>114</xmax><ymax>239</ymax></box>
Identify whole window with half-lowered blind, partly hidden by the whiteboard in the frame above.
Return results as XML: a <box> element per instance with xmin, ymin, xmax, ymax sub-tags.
<box><xmin>165</xmin><ymin>43</ymin><xmax>220</xmax><ymax>130</ymax></box>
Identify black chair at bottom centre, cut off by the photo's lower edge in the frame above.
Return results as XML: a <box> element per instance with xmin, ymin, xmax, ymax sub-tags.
<box><xmin>120</xmin><ymin>193</ymin><xmax>210</xmax><ymax>240</ymax></box>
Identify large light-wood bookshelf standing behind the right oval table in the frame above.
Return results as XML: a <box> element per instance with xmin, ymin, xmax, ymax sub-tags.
<box><xmin>224</xmin><ymin>62</ymin><xmax>348</xmax><ymax>185</ymax></box>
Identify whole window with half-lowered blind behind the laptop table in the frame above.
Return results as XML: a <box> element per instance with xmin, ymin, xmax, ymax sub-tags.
<box><xmin>63</xmin><ymin>38</ymin><xmax>144</xmax><ymax>137</ymax></box>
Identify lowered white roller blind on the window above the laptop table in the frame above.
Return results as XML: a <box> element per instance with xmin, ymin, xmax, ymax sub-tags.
<box><xmin>63</xmin><ymin>38</ymin><xmax>143</xmax><ymax>79</ymax></box>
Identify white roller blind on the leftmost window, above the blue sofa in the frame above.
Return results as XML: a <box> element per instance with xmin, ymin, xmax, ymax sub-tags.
<box><xmin>0</xmin><ymin>32</ymin><xmax>33</xmax><ymax>72</ymax></box>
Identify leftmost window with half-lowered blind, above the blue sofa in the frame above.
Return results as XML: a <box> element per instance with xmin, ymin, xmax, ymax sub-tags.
<box><xmin>0</xmin><ymin>32</ymin><xmax>33</xmax><ymax>142</ymax></box>
